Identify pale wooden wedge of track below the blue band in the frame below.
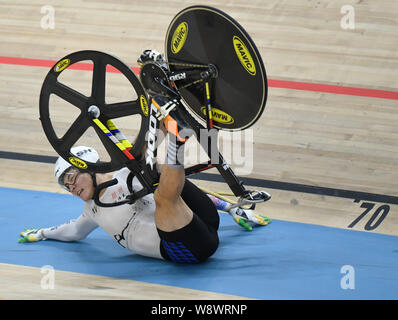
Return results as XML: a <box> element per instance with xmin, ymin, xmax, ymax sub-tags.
<box><xmin>0</xmin><ymin>263</ymin><xmax>249</xmax><ymax>300</ymax></box>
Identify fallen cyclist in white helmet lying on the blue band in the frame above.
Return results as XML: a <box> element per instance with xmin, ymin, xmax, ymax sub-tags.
<box><xmin>20</xmin><ymin>50</ymin><xmax>270</xmax><ymax>263</ymax></box>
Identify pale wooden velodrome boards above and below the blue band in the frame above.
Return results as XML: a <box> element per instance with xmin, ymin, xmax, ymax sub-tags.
<box><xmin>0</xmin><ymin>0</ymin><xmax>398</xmax><ymax>299</ymax></box>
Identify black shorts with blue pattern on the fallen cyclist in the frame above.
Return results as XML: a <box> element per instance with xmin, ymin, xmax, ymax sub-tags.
<box><xmin>158</xmin><ymin>180</ymin><xmax>220</xmax><ymax>264</ymax></box>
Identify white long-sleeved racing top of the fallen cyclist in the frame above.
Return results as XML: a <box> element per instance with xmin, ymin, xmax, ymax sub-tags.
<box><xmin>42</xmin><ymin>168</ymin><xmax>163</xmax><ymax>259</ymax></box>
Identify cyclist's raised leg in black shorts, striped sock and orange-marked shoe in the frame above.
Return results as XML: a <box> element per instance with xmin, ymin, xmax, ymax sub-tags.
<box><xmin>154</xmin><ymin>95</ymin><xmax>218</xmax><ymax>263</ymax></box>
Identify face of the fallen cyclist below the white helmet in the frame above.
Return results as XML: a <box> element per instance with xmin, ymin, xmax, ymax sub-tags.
<box><xmin>64</xmin><ymin>168</ymin><xmax>94</xmax><ymax>201</ymax></box>
